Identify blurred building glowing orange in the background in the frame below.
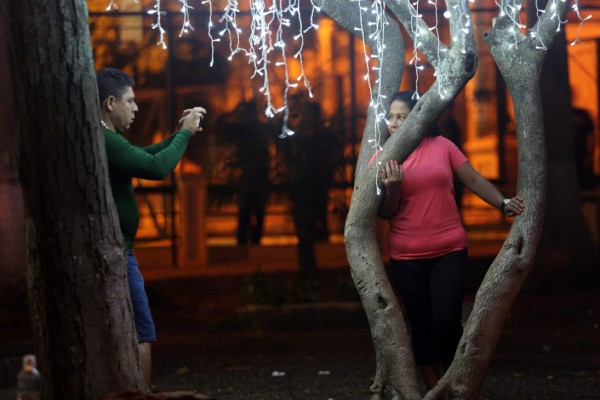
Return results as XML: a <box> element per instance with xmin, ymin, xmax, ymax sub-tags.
<box><xmin>88</xmin><ymin>0</ymin><xmax>600</xmax><ymax>266</ymax></box>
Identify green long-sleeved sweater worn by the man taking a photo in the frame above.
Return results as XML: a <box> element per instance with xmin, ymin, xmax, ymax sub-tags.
<box><xmin>102</xmin><ymin>127</ymin><xmax>192</xmax><ymax>250</ymax></box>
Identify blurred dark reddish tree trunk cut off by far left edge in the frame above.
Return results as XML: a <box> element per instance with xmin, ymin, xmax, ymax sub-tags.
<box><xmin>0</xmin><ymin>2</ymin><xmax>26</xmax><ymax>306</ymax></box>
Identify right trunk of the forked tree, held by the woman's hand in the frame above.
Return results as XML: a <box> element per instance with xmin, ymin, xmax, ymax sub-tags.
<box><xmin>426</xmin><ymin>2</ymin><xmax>568</xmax><ymax>400</ymax></box>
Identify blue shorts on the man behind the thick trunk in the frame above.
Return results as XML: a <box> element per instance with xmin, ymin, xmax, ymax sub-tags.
<box><xmin>127</xmin><ymin>250</ymin><xmax>156</xmax><ymax>343</ymax></box>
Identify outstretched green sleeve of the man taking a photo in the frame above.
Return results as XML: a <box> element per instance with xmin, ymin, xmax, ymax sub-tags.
<box><xmin>106</xmin><ymin>130</ymin><xmax>192</xmax><ymax>180</ymax></box>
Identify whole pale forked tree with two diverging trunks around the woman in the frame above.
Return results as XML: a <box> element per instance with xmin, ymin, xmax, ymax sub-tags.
<box><xmin>323</xmin><ymin>0</ymin><xmax>568</xmax><ymax>400</ymax></box>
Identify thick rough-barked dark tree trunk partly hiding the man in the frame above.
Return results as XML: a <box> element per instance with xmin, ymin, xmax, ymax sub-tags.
<box><xmin>7</xmin><ymin>0</ymin><xmax>147</xmax><ymax>400</ymax></box>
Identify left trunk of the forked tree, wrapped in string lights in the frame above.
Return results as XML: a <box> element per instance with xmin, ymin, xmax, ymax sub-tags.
<box><xmin>316</xmin><ymin>1</ymin><xmax>477</xmax><ymax>399</ymax></box>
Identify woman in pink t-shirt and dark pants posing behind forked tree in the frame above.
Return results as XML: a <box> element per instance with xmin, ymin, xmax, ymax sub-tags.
<box><xmin>379</xmin><ymin>92</ymin><xmax>524</xmax><ymax>388</ymax></box>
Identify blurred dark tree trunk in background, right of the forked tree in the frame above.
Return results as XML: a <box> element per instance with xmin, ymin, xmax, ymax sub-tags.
<box><xmin>534</xmin><ymin>32</ymin><xmax>600</xmax><ymax>287</ymax></box>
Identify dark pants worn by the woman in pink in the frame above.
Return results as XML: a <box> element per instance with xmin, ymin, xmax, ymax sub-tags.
<box><xmin>390</xmin><ymin>249</ymin><xmax>467</xmax><ymax>365</ymax></box>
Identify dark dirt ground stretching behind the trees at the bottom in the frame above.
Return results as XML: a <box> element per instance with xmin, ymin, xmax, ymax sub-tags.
<box><xmin>0</xmin><ymin>270</ymin><xmax>600</xmax><ymax>400</ymax></box>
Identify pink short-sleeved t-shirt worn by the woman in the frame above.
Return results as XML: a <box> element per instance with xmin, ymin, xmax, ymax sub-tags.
<box><xmin>380</xmin><ymin>136</ymin><xmax>467</xmax><ymax>260</ymax></box>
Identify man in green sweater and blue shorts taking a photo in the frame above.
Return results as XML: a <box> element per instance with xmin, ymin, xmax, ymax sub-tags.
<box><xmin>96</xmin><ymin>68</ymin><xmax>206</xmax><ymax>383</ymax></box>
